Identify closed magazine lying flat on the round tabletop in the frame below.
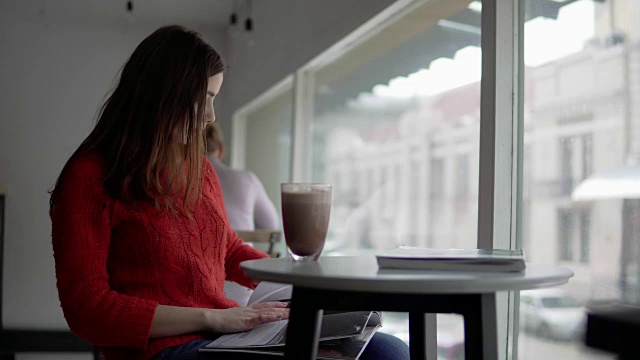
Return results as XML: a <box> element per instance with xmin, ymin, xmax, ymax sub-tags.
<box><xmin>376</xmin><ymin>246</ymin><xmax>525</xmax><ymax>272</ymax></box>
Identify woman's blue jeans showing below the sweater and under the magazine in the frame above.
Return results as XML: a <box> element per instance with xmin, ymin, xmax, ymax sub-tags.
<box><xmin>159</xmin><ymin>332</ymin><xmax>409</xmax><ymax>360</ymax></box>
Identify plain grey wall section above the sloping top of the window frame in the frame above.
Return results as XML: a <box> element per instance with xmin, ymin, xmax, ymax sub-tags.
<box><xmin>216</xmin><ymin>0</ymin><xmax>394</xmax><ymax>153</ymax></box>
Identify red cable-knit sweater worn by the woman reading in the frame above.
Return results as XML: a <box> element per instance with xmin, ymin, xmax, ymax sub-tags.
<box><xmin>51</xmin><ymin>154</ymin><xmax>267</xmax><ymax>360</ymax></box>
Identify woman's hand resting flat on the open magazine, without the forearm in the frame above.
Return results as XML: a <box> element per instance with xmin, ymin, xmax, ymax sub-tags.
<box><xmin>205</xmin><ymin>301</ymin><xmax>289</xmax><ymax>333</ymax></box>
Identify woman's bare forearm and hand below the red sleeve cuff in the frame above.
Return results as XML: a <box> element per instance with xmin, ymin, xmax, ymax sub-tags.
<box><xmin>150</xmin><ymin>302</ymin><xmax>289</xmax><ymax>338</ymax></box>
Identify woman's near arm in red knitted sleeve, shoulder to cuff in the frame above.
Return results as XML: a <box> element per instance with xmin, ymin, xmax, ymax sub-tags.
<box><xmin>51</xmin><ymin>155</ymin><xmax>158</xmax><ymax>350</ymax></box>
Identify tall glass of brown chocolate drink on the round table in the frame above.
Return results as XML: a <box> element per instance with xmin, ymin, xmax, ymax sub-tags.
<box><xmin>280</xmin><ymin>183</ymin><xmax>332</xmax><ymax>261</ymax></box>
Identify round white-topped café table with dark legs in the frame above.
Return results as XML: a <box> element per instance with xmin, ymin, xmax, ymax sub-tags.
<box><xmin>241</xmin><ymin>256</ymin><xmax>573</xmax><ymax>360</ymax></box>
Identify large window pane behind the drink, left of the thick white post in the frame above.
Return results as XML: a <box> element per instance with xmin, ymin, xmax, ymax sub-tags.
<box><xmin>305</xmin><ymin>0</ymin><xmax>481</xmax><ymax>253</ymax></box>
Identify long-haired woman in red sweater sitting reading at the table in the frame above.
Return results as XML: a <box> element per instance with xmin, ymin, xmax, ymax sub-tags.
<box><xmin>50</xmin><ymin>26</ymin><xmax>408</xmax><ymax>360</ymax></box>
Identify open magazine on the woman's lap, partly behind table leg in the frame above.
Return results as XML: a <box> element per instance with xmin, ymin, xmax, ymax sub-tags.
<box><xmin>200</xmin><ymin>281</ymin><xmax>382</xmax><ymax>360</ymax></box>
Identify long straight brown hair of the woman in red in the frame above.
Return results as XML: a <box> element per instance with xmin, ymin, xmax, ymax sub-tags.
<box><xmin>49</xmin><ymin>25</ymin><xmax>224</xmax><ymax>214</ymax></box>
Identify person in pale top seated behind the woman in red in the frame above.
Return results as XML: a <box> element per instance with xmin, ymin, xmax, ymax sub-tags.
<box><xmin>206</xmin><ymin>124</ymin><xmax>280</xmax><ymax>231</ymax></box>
